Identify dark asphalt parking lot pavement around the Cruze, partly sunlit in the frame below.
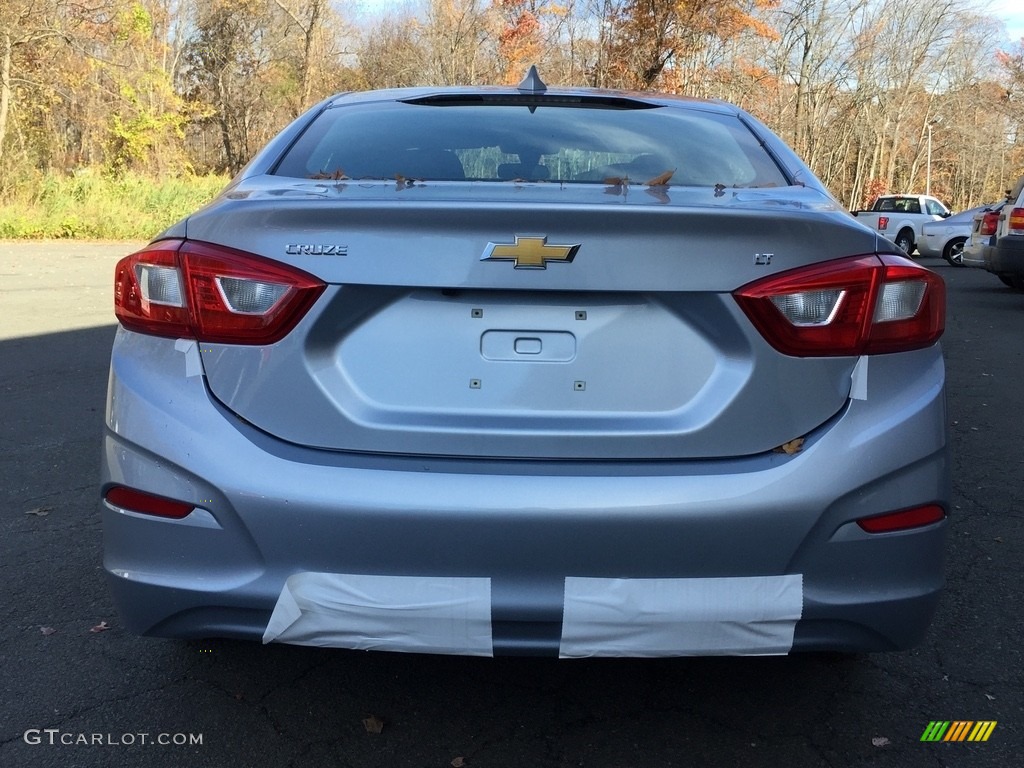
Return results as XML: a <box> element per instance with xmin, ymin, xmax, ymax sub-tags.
<box><xmin>0</xmin><ymin>242</ymin><xmax>1024</xmax><ymax>768</ymax></box>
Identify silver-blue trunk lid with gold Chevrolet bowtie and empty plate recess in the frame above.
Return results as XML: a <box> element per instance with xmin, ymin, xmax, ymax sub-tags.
<box><xmin>187</xmin><ymin>179</ymin><xmax>876</xmax><ymax>460</ymax></box>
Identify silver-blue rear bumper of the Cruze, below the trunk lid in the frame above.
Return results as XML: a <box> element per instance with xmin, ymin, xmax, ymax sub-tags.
<box><xmin>101</xmin><ymin>331</ymin><xmax>949</xmax><ymax>655</ymax></box>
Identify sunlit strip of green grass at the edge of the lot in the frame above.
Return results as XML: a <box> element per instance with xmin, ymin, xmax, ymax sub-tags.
<box><xmin>0</xmin><ymin>169</ymin><xmax>228</xmax><ymax>240</ymax></box>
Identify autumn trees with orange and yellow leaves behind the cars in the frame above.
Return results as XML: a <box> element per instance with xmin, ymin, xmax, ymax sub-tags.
<box><xmin>0</xmin><ymin>0</ymin><xmax>1024</xmax><ymax>209</ymax></box>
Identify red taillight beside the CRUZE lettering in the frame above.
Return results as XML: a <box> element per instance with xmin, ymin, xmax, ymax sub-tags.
<box><xmin>114</xmin><ymin>240</ymin><xmax>326</xmax><ymax>344</ymax></box>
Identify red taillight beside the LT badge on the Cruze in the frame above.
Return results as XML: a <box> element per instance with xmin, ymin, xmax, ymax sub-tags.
<box><xmin>734</xmin><ymin>254</ymin><xmax>945</xmax><ymax>357</ymax></box>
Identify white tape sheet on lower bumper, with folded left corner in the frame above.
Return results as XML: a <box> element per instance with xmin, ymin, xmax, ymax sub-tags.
<box><xmin>263</xmin><ymin>572</ymin><xmax>494</xmax><ymax>656</ymax></box>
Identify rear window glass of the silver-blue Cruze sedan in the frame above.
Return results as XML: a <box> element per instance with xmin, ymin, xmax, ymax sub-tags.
<box><xmin>274</xmin><ymin>101</ymin><xmax>787</xmax><ymax>186</ymax></box>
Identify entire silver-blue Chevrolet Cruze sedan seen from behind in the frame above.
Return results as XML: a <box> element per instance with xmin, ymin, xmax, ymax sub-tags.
<box><xmin>100</xmin><ymin>73</ymin><xmax>949</xmax><ymax>657</ymax></box>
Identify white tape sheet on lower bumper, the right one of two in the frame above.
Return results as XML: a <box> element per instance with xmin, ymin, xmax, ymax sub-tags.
<box><xmin>559</xmin><ymin>573</ymin><xmax>804</xmax><ymax>658</ymax></box>
